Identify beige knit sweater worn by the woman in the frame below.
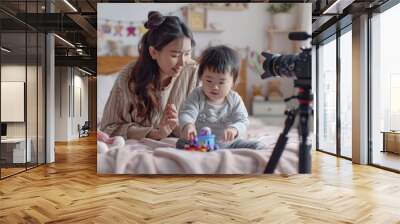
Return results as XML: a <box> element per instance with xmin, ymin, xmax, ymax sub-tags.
<box><xmin>100</xmin><ymin>62</ymin><xmax>199</xmax><ymax>139</ymax></box>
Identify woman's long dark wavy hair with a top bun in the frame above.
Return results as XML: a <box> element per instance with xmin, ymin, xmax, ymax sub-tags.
<box><xmin>129</xmin><ymin>11</ymin><xmax>195</xmax><ymax>122</ymax></box>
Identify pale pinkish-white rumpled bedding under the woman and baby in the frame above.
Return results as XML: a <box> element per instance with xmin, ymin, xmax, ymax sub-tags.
<box><xmin>97</xmin><ymin>119</ymin><xmax>298</xmax><ymax>174</ymax></box>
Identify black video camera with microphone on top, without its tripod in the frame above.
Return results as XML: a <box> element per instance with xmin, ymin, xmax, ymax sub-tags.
<box><xmin>261</xmin><ymin>32</ymin><xmax>311</xmax><ymax>88</ymax></box>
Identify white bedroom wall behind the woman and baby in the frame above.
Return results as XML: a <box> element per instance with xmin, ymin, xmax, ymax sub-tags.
<box><xmin>97</xmin><ymin>3</ymin><xmax>311</xmax><ymax>56</ymax></box>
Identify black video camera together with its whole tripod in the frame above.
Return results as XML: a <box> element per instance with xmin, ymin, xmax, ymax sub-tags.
<box><xmin>261</xmin><ymin>32</ymin><xmax>312</xmax><ymax>173</ymax></box>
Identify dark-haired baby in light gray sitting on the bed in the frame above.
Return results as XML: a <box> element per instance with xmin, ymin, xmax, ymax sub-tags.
<box><xmin>177</xmin><ymin>45</ymin><xmax>264</xmax><ymax>149</ymax></box>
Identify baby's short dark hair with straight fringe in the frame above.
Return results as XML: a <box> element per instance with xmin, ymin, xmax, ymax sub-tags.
<box><xmin>198</xmin><ymin>45</ymin><xmax>240</xmax><ymax>83</ymax></box>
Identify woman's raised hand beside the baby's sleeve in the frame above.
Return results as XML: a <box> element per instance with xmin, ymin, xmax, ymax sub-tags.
<box><xmin>159</xmin><ymin>104</ymin><xmax>178</xmax><ymax>139</ymax></box>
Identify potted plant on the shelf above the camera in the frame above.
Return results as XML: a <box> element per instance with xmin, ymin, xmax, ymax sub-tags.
<box><xmin>267</xmin><ymin>3</ymin><xmax>295</xmax><ymax>30</ymax></box>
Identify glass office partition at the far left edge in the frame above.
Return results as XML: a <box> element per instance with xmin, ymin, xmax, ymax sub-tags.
<box><xmin>0</xmin><ymin>1</ymin><xmax>46</xmax><ymax>178</ymax></box>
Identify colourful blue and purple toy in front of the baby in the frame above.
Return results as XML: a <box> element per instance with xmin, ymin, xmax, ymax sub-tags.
<box><xmin>185</xmin><ymin>127</ymin><xmax>219</xmax><ymax>152</ymax></box>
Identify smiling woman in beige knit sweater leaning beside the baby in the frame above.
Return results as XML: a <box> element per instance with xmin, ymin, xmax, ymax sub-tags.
<box><xmin>100</xmin><ymin>11</ymin><xmax>198</xmax><ymax>140</ymax></box>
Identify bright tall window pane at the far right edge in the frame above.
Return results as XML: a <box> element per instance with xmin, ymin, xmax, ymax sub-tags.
<box><xmin>370</xmin><ymin>1</ymin><xmax>400</xmax><ymax>170</ymax></box>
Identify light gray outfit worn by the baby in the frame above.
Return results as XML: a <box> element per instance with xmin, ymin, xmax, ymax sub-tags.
<box><xmin>177</xmin><ymin>87</ymin><xmax>264</xmax><ymax>149</ymax></box>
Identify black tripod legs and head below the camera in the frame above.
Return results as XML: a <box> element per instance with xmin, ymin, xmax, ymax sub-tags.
<box><xmin>264</xmin><ymin>80</ymin><xmax>312</xmax><ymax>174</ymax></box>
